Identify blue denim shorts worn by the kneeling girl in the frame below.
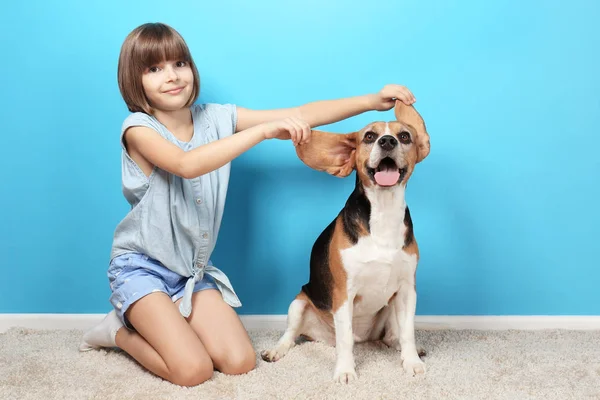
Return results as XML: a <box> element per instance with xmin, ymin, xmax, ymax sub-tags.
<box><xmin>108</xmin><ymin>253</ymin><xmax>217</xmax><ymax>330</ymax></box>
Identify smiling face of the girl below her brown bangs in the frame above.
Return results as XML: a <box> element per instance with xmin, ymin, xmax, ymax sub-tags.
<box><xmin>142</xmin><ymin>61</ymin><xmax>194</xmax><ymax>111</ymax></box>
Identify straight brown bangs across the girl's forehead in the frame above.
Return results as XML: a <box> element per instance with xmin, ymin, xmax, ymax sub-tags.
<box><xmin>133</xmin><ymin>25</ymin><xmax>191</xmax><ymax>70</ymax></box>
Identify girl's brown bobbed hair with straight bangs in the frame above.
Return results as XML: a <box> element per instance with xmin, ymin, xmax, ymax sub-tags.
<box><xmin>117</xmin><ymin>23</ymin><xmax>200</xmax><ymax>114</ymax></box>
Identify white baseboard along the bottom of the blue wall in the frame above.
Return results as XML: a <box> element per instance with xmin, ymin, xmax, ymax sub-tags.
<box><xmin>0</xmin><ymin>314</ymin><xmax>600</xmax><ymax>333</ymax></box>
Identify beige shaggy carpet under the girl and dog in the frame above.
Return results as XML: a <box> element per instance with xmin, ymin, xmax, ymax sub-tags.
<box><xmin>0</xmin><ymin>329</ymin><xmax>600</xmax><ymax>400</ymax></box>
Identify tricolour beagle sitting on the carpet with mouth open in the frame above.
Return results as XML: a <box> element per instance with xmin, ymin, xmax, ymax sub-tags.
<box><xmin>261</xmin><ymin>101</ymin><xmax>429</xmax><ymax>383</ymax></box>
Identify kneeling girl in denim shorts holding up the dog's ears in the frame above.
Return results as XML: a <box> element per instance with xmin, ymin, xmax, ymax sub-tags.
<box><xmin>80</xmin><ymin>23</ymin><xmax>415</xmax><ymax>386</ymax></box>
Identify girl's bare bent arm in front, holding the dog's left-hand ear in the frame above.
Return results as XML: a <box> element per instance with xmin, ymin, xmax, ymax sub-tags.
<box><xmin>125</xmin><ymin>118</ymin><xmax>311</xmax><ymax>179</ymax></box>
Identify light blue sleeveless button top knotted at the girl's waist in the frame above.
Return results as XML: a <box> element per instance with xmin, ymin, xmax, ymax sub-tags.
<box><xmin>111</xmin><ymin>104</ymin><xmax>241</xmax><ymax>317</ymax></box>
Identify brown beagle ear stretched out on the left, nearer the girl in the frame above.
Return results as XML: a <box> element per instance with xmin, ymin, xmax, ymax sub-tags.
<box><xmin>296</xmin><ymin>130</ymin><xmax>356</xmax><ymax>178</ymax></box>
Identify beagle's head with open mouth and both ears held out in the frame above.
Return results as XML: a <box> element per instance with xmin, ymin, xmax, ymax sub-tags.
<box><xmin>296</xmin><ymin>101</ymin><xmax>429</xmax><ymax>187</ymax></box>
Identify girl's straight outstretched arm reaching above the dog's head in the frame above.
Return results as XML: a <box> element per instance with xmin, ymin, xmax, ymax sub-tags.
<box><xmin>236</xmin><ymin>85</ymin><xmax>415</xmax><ymax>132</ymax></box>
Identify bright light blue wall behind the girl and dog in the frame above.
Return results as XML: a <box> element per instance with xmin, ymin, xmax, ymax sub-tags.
<box><xmin>0</xmin><ymin>0</ymin><xmax>600</xmax><ymax>314</ymax></box>
